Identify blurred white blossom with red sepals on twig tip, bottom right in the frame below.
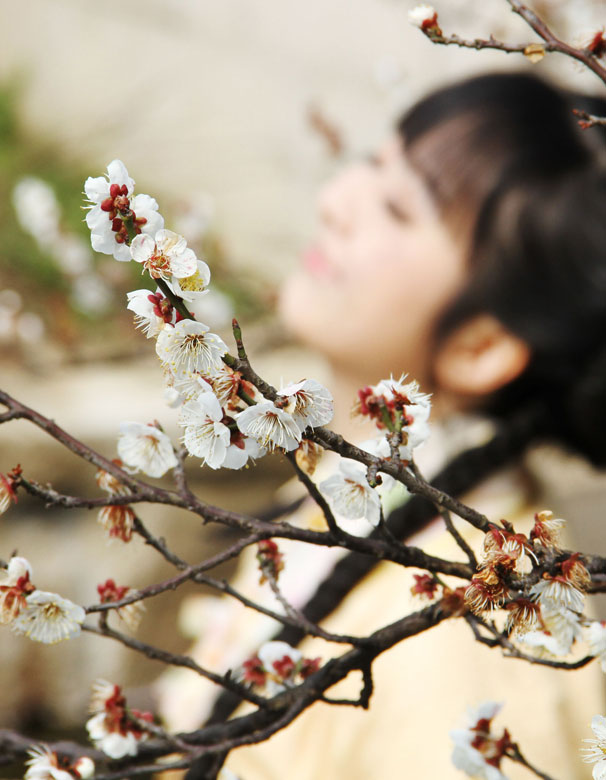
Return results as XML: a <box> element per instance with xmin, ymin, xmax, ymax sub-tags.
<box><xmin>450</xmin><ymin>701</ymin><xmax>507</xmax><ymax>780</ymax></box>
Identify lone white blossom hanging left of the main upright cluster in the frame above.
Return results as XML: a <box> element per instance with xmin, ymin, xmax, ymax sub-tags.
<box><xmin>118</xmin><ymin>421</ymin><xmax>177</xmax><ymax>477</ymax></box>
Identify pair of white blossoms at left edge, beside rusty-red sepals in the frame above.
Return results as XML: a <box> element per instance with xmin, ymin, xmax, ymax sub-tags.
<box><xmin>0</xmin><ymin>555</ymin><xmax>86</xmax><ymax>644</ymax></box>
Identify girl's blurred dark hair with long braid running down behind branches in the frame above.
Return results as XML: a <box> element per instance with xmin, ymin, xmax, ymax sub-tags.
<box><xmin>192</xmin><ymin>74</ymin><xmax>606</xmax><ymax>748</ymax></box>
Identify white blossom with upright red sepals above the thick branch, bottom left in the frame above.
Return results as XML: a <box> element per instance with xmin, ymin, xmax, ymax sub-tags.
<box><xmin>86</xmin><ymin>680</ymin><xmax>153</xmax><ymax>758</ymax></box>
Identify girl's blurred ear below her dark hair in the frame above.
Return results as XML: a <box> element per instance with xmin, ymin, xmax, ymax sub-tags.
<box><xmin>434</xmin><ymin>314</ymin><xmax>530</xmax><ymax>400</ymax></box>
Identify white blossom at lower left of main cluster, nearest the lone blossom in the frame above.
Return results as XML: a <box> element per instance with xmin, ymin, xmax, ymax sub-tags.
<box><xmin>179</xmin><ymin>392</ymin><xmax>231</xmax><ymax>469</ymax></box>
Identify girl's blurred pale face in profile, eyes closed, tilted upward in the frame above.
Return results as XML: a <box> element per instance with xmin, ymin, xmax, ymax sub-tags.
<box><xmin>280</xmin><ymin>139</ymin><xmax>466</xmax><ymax>389</ymax></box>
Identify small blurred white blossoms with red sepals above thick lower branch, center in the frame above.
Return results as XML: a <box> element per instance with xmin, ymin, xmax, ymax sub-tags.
<box><xmin>241</xmin><ymin>641</ymin><xmax>320</xmax><ymax>696</ymax></box>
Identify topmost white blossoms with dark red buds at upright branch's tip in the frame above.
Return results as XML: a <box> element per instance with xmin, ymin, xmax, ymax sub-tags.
<box><xmin>84</xmin><ymin>160</ymin><xmax>164</xmax><ymax>262</ymax></box>
